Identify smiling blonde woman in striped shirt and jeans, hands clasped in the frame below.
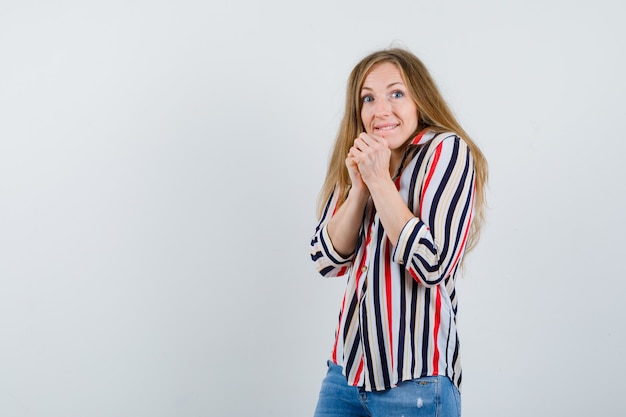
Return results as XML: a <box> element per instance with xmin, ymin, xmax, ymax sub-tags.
<box><xmin>311</xmin><ymin>48</ymin><xmax>487</xmax><ymax>417</ymax></box>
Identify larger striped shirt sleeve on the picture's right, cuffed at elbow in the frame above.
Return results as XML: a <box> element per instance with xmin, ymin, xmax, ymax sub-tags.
<box><xmin>393</xmin><ymin>136</ymin><xmax>475</xmax><ymax>287</ymax></box>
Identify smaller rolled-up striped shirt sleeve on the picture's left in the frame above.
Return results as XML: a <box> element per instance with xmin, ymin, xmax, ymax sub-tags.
<box><xmin>311</xmin><ymin>188</ymin><xmax>354</xmax><ymax>277</ymax></box>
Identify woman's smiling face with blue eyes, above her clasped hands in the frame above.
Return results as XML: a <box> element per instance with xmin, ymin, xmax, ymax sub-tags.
<box><xmin>361</xmin><ymin>62</ymin><xmax>418</xmax><ymax>151</ymax></box>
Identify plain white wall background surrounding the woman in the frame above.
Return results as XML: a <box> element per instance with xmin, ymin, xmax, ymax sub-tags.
<box><xmin>0</xmin><ymin>0</ymin><xmax>626</xmax><ymax>417</ymax></box>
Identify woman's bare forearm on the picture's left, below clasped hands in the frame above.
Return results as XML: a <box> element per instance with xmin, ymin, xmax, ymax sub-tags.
<box><xmin>327</xmin><ymin>188</ymin><xmax>369</xmax><ymax>256</ymax></box>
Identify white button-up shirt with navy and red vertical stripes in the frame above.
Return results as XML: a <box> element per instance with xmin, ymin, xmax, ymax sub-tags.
<box><xmin>311</xmin><ymin>130</ymin><xmax>475</xmax><ymax>391</ymax></box>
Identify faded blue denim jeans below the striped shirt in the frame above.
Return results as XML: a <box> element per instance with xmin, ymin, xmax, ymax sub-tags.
<box><xmin>315</xmin><ymin>361</ymin><xmax>461</xmax><ymax>417</ymax></box>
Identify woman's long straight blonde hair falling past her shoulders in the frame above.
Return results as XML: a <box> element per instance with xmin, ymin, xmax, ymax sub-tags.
<box><xmin>318</xmin><ymin>48</ymin><xmax>488</xmax><ymax>252</ymax></box>
